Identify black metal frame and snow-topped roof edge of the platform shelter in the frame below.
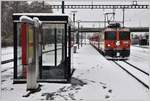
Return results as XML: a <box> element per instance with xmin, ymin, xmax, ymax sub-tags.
<box><xmin>13</xmin><ymin>13</ymin><xmax>73</xmax><ymax>83</ymax></box>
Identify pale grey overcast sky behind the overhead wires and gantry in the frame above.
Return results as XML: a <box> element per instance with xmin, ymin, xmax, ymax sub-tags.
<box><xmin>47</xmin><ymin>0</ymin><xmax>150</xmax><ymax>27</ymax></box>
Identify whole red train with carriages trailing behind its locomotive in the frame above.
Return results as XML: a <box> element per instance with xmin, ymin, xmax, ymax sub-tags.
<box><xmin>89</xmin><ymin>23</ymin><xmax>131</xmax><ymax>59</ymax></box>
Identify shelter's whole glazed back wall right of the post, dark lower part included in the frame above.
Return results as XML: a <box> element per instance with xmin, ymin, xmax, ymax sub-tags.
<box><xmin>41</xmin><ymin>23</ymin><xmax>66</xmax><ymax>79</ymax></box>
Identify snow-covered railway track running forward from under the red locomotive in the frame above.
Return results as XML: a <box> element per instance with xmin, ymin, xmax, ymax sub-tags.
<box><xmin>113</xmin><ymin>61</ymin><xmax>149</xmax><ymax>89</ymax></box>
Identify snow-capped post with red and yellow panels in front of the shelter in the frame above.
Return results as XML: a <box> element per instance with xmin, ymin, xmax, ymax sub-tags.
<box><xmin>20</xmin><ymin>16</ymin><xmax>41</xmax><ymax>91</ymax></box>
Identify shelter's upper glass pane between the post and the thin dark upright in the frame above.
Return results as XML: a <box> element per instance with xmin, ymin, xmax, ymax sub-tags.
<box><xmin>42</xmin><ymin>24</ymin><xmax>55</xmax><ymax>66</ymax></box>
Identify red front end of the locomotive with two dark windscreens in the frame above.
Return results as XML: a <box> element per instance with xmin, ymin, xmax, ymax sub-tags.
<box><xmin>104</xmin><ymin>23</ymin><xmax>131</xmax><ymax>59</ymax></box>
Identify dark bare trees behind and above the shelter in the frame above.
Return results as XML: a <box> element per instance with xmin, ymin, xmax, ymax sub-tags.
<box><xmin>1</xmin><ymin>1</ymin><xmax>52</xmax><ymax>47</ymax></box>
